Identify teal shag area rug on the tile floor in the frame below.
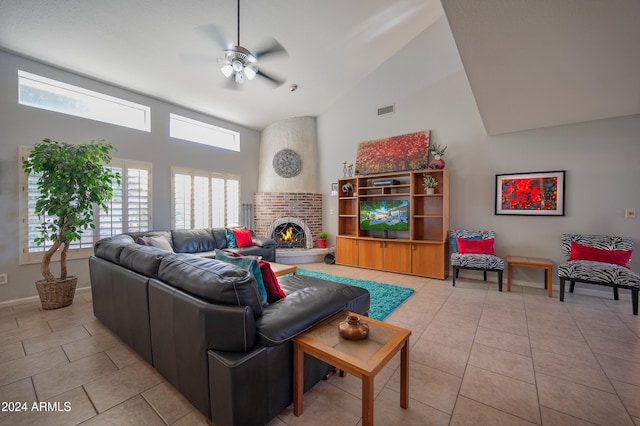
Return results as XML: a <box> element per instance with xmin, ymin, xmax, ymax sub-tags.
<box><xmin>298</xmin><ymin>268</ymin><xmax>414</xmax><ymax>321</ymax></box>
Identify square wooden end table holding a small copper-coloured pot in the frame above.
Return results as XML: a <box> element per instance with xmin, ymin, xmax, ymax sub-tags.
<box><xmin>293</xmin><ymin>312</ymin><xmax>411</xmax><ymax>426</ymax></box>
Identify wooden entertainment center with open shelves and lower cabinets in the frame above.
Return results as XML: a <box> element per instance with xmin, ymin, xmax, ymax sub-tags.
<box><xmin>336</xmin><ymin>169</ymin><xmax>449</xmax><ymax>279</ymax></box>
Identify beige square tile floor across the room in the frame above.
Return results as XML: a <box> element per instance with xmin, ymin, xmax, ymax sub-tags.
<box><xmin>0</xmin><ymin>263</ymin><xmax>640</xmax><ymax>426</ymax></box>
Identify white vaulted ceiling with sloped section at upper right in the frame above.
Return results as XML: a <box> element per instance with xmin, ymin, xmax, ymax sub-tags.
<box><xmin>0</xmin><ymin>0</ymin><xmax>640</xmax><ymax>134</ymax></box>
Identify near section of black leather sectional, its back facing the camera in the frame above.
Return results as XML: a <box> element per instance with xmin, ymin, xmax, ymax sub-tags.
<box><xmin>89</xmin><ymin>233</ymin><xmax>369</xmax><ymax>426</ymax></box>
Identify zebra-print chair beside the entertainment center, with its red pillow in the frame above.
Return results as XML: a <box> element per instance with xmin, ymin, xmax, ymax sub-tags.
<box><xmin>449</xmin><ymin>229</ymin><xmax>504</xmax><ymax>291</ymax></box>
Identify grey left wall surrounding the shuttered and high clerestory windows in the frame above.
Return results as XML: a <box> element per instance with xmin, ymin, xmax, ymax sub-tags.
<box><xmin>0</xmin><ymin>52</ymin><xmax>260</xmax><ymax>302</ymax></box>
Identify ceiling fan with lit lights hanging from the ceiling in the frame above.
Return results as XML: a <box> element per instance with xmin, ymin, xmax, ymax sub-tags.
<box><xmin>198</xmin><ymin>0</ymin><xmax>287</xmax><ymax>88</ymax></box>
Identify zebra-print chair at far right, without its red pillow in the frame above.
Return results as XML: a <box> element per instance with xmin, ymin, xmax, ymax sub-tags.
<box><xmin>558</xmin><ymin>234</ymin><xmax>640</xmax><ymax>315</ymax></box>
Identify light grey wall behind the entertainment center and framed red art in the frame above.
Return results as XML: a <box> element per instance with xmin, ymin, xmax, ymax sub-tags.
<box><xmin>318</xmin><ymin>17</ymin><xmax>640</xmax><ymax>289</ymax></box>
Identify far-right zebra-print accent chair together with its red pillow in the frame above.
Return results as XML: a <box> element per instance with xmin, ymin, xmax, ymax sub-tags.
<box><xmin>558</xmin><ymin>234</ymin><xmax>640</xmax><ymax>315</ymax></box>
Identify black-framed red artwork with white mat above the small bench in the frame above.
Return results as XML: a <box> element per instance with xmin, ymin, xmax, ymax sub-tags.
<box><xmin>495</xmin><ymin>170</ymin><xmax>565</xmax><ymax>216</ymax></box>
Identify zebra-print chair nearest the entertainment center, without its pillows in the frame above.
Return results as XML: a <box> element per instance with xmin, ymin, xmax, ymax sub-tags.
<box><xmin>450</xmin><ymin>229</ymin><xmax>504</xmax><ymax>291</ymax></box>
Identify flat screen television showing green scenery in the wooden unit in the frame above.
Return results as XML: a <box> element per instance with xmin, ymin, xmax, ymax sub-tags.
<box><xmin>360</xmin><ymin>200</ymin><xmax>409</xmax><ymax>231</ymax></box>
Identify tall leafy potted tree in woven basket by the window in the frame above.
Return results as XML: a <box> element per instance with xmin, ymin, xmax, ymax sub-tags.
<box><xmin>22</xmin><ymin>139</ymin><xmax>120</xmax><ymax>309</ymax></box>
